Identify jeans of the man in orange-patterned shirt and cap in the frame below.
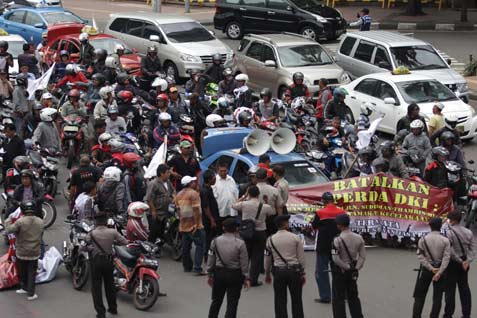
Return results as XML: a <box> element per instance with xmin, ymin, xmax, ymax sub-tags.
<box><xmin>182</xmin><ymin>229</ymin><xmax>205</xmax><ymax>272</ymax></box>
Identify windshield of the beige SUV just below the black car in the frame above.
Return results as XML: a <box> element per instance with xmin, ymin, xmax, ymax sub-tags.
<box><xmin>278</xmin><ymin>45</ymin><xmax>333</xmax><ymax>67</ymax></box>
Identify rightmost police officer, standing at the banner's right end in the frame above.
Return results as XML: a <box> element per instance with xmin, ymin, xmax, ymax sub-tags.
<box><xmin>444</xmin><ymin>211</ymin><xmax>475</xmax><ymax>318</ymax></box>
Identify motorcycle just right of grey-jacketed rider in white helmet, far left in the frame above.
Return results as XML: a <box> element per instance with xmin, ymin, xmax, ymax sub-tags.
<box><xmin>61</xmin><ymin>115</ymin><xmax>84</xmax><ymax>169</ymax></box>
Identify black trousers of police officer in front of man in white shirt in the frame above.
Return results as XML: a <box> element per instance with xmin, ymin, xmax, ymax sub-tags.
<box><xmin>209</xmin><ymin>269</ymin><xmax>244</xmax><ymax>318</ymax></box>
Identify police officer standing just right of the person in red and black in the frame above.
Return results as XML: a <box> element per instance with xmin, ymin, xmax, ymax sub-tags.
<box><xmin>331</xmin><ymin>213</ymin><xmax>366</xmax><ymax>318</ymax></box>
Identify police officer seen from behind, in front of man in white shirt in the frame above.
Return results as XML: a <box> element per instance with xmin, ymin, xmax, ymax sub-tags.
<box><xmin>207</xmin><ymin>218</ymin><xmax>250</xmax><ymax>318</ymax></box>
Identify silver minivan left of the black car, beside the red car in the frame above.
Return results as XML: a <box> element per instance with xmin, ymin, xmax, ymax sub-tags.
<box><xmin>105</xmin><ymin>12</ymin><xmax>234</xmax><ymax>80</ymax></box>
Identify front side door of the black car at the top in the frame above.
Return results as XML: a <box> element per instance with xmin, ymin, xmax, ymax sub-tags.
<box><xmin>264</xmin><ymin>0</ymin><xmax>299</xmax><ymax>32</ymax></box>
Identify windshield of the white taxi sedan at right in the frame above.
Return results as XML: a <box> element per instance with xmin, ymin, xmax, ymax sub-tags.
<box><xmin>396</xmin><ymin>81</ymin><xmax>457</xmax><ymax>104</ymax></box>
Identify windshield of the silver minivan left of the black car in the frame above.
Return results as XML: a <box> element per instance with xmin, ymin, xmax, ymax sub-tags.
<box><xmin>161</xmin><ymin>22</ymin><xmax>215</xmax><ymax>43</ymax></box>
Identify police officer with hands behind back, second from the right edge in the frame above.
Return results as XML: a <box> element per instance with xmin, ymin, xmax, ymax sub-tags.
<box><xmin>412</xmin><ymin>217</ymin><xmax>451</xmax><ymax>318</ymax></box>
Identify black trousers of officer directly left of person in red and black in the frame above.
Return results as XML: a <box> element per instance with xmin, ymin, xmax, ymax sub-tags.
<box><xmin>273</xmin><ymin>270</ymin><xmax>304</xmax><ymax>318</ymax></box>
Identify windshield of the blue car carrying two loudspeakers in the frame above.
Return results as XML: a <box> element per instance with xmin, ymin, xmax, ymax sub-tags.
<box><xmin>272</xmin><ymin>161</ymin><xmax>328</xmax><ymax>187</ymax></box>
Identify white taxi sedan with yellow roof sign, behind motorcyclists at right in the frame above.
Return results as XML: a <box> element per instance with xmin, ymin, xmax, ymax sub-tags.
<box><xmin>341</xmin><ymin>72</ymin><xmax>477</xmax><ymax>139</ymax></box>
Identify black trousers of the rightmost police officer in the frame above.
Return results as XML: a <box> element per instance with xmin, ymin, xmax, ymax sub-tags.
<box><xmin>444</xmin><ymin>261</ymin><xmax>472</xmax><ymax>318</ymax></box>
